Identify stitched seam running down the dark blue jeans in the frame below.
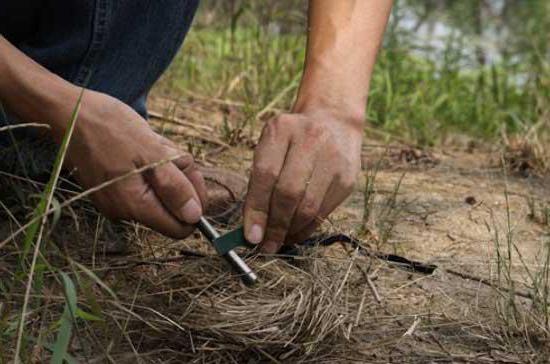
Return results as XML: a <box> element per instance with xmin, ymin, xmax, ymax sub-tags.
<box><xmin>74</xmin><ymin>0</ymin><xmax>111</xmax><ymax>87</ymax></box>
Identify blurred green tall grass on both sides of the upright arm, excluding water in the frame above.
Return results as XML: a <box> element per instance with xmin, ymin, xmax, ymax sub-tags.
<box><xmin>156</xmin><ymin>3</ymin><xmax>550</xmax><ymax>145</ymax></box>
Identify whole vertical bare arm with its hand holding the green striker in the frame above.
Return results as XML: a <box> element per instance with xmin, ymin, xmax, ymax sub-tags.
<box><xmin>244</xmin><ymin>0</ymin><xmax>392</xmax><ymax>253</ymax></box>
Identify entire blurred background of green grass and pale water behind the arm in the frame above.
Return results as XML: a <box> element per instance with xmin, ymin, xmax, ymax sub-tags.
<box><xmin>157</xmin><ymin>0</ymin><xmax>550</xmax><ymax>145</ymax></box>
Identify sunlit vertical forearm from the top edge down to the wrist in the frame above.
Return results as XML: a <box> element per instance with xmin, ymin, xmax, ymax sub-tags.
<box><xmin>295</xmin><ymin>0</ymin><xmax>392</xmax><ymax>122</ymax></box>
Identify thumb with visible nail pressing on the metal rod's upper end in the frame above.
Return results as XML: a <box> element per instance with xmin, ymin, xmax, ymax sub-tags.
<box><xmin>145</xmin><ymin>163</ymin><xmax>202</xmax><ymax>224</ymax></box>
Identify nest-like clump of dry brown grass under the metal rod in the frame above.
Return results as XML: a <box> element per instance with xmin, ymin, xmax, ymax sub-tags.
<box><xmin>109</xmin><ymin>246</ymin><xmax>380</xmax><ymax>363</ymax></box>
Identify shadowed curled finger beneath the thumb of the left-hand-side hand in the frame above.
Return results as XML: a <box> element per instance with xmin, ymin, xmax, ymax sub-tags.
<box><xmin>132</xmin><ymin>181</ymin><xmax>194</xmax><ymax>239</ymax></box>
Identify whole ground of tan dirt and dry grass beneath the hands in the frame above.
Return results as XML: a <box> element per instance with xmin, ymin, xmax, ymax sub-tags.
<box><xmin>0</xmin><ymin>97</ymin><xmax>550</xmax><ymax>363</ymax></box>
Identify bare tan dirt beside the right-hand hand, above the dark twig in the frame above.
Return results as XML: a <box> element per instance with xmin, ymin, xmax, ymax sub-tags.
<box><xmin>151</xmin><ymin>93</ymin><xmax>550</xmax><ymax>278</ymax></box>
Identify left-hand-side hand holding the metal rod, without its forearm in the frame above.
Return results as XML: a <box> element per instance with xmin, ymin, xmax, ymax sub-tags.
<box><xmin>58</xmin><ymin>90</ymin><xmax>206</xmax><ymax>238</ymax></box>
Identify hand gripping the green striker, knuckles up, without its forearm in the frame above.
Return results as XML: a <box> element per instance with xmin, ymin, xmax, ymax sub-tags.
<box><xmin>244</xmin><ymin>110</ymin><xmax>363</xmax><ymax>253</ymax></box>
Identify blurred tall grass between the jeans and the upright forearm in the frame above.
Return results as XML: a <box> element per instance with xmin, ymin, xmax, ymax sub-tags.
<box><xmin>163</xmin><ymin>27</ymin><xmax>305</xmax><ymax>110</ymax></box>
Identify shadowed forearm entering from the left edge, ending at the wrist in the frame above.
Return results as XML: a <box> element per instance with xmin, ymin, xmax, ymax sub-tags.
<box><xmin>0</xmin><ymin>35</ymin><xmax>78</xmax><ymax>139</ymax></box>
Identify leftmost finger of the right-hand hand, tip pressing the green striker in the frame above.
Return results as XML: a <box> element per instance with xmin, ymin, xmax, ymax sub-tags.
<box><xmin>244</xmin><ymin>119</ymin><xmax>289</xmax><ymax>244</ymax></box>
